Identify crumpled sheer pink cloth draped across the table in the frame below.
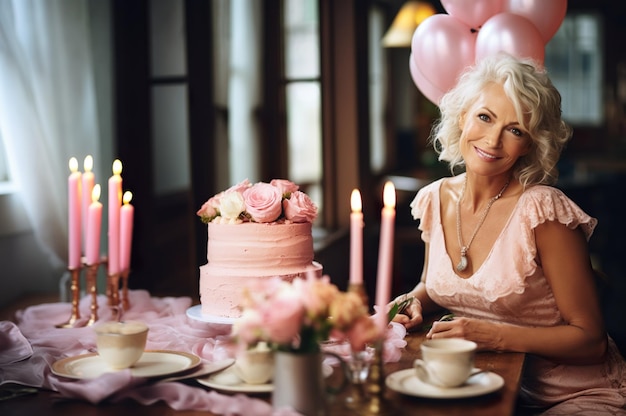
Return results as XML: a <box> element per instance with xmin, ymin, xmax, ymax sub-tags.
<box><xmin>0</xmin><ymin>290</ymin><xmax>406</xmax><ymax>415</ymax></box>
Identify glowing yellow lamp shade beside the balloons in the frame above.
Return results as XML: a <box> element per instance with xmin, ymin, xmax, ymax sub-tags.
<box><xmin>382</xmin><ymin>1</ymin><xmax>436</xmax><ymax>48</ymax></box>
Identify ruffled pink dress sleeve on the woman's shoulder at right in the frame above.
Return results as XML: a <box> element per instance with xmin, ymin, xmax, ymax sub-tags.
<box><xmin>522</xmin><ymin>185</ymin><xmax>598</xmax><ymax>241</ymax></box>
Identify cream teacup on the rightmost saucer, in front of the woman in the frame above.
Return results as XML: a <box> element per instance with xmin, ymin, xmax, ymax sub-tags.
<box><xmin>413</xmin><ymin>338</ymin><xmax>477</xmax><ymax>387</ymax></box>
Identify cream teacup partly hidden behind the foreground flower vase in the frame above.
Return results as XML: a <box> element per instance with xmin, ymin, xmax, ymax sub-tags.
<box><xmin>234</xmin><ymin>343</ymin><xmax>274</xmax><ymax>384</ymax></box>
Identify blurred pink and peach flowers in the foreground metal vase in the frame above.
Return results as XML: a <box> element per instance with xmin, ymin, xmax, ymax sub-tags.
<box><xmin>232</xmin><ymin>276</ymin><xmax>381</xmax><ymax>353</ymax></box>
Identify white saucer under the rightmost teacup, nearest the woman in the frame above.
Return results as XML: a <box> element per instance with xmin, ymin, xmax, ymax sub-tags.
<box><xmin>385</xmin><ymin>368</ymin><xmax>504</xmax><ymax>399</ymax></box>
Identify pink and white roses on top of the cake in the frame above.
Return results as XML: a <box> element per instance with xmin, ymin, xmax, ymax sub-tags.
<box><xmin>197</xmin><ymin>179</ymin><xmax>317</xmax><ymax>224</ymax></box>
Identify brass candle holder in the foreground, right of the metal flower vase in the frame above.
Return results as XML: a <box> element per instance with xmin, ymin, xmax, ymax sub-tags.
<box><xmin>359</xmin><ymin>336</ymin><xmax>394</xmax><ymax>415</ymax></box>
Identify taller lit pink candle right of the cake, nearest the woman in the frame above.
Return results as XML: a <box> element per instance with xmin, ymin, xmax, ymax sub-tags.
<box><xmin>376</xmin><ymin>182</ymin><xmax>396</xmax><ymax>331</ymax></box>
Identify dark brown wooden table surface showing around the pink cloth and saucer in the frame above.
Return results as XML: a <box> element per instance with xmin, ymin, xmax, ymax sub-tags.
<box><xmin>0</xmin><ymin>300</ymin><xmax>524</xmax><ymax>416</ymax></box>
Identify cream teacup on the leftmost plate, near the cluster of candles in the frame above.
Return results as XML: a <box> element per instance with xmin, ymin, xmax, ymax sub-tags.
<box><xmin>95</xmin><ymin>322</ymin><xmax>148</xmax><ymax>370</ymax></box>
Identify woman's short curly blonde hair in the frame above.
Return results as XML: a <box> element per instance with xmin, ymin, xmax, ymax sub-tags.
<box><xmin>431</xmin><ymin>53</ymin><xmax>572</xmax><ymax>186</ymax></box>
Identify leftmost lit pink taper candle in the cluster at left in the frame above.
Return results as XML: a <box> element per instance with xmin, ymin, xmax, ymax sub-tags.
<box><xmin>67</xmin><ymin>157</ymin><xmax>82</xmax><ymax>269</ymax></box>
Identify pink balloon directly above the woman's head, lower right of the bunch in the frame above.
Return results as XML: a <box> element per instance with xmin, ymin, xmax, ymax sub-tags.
<box><xmin>476</xmin><ymin>13</ymin><xmax>545</xmax><ymax>64</ymax></box>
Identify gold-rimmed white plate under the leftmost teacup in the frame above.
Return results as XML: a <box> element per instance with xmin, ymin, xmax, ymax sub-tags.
<box><xmin>52</xmin><ymin>350</ymin><xmax>201</xmax><ymax>379</ymax></box>
